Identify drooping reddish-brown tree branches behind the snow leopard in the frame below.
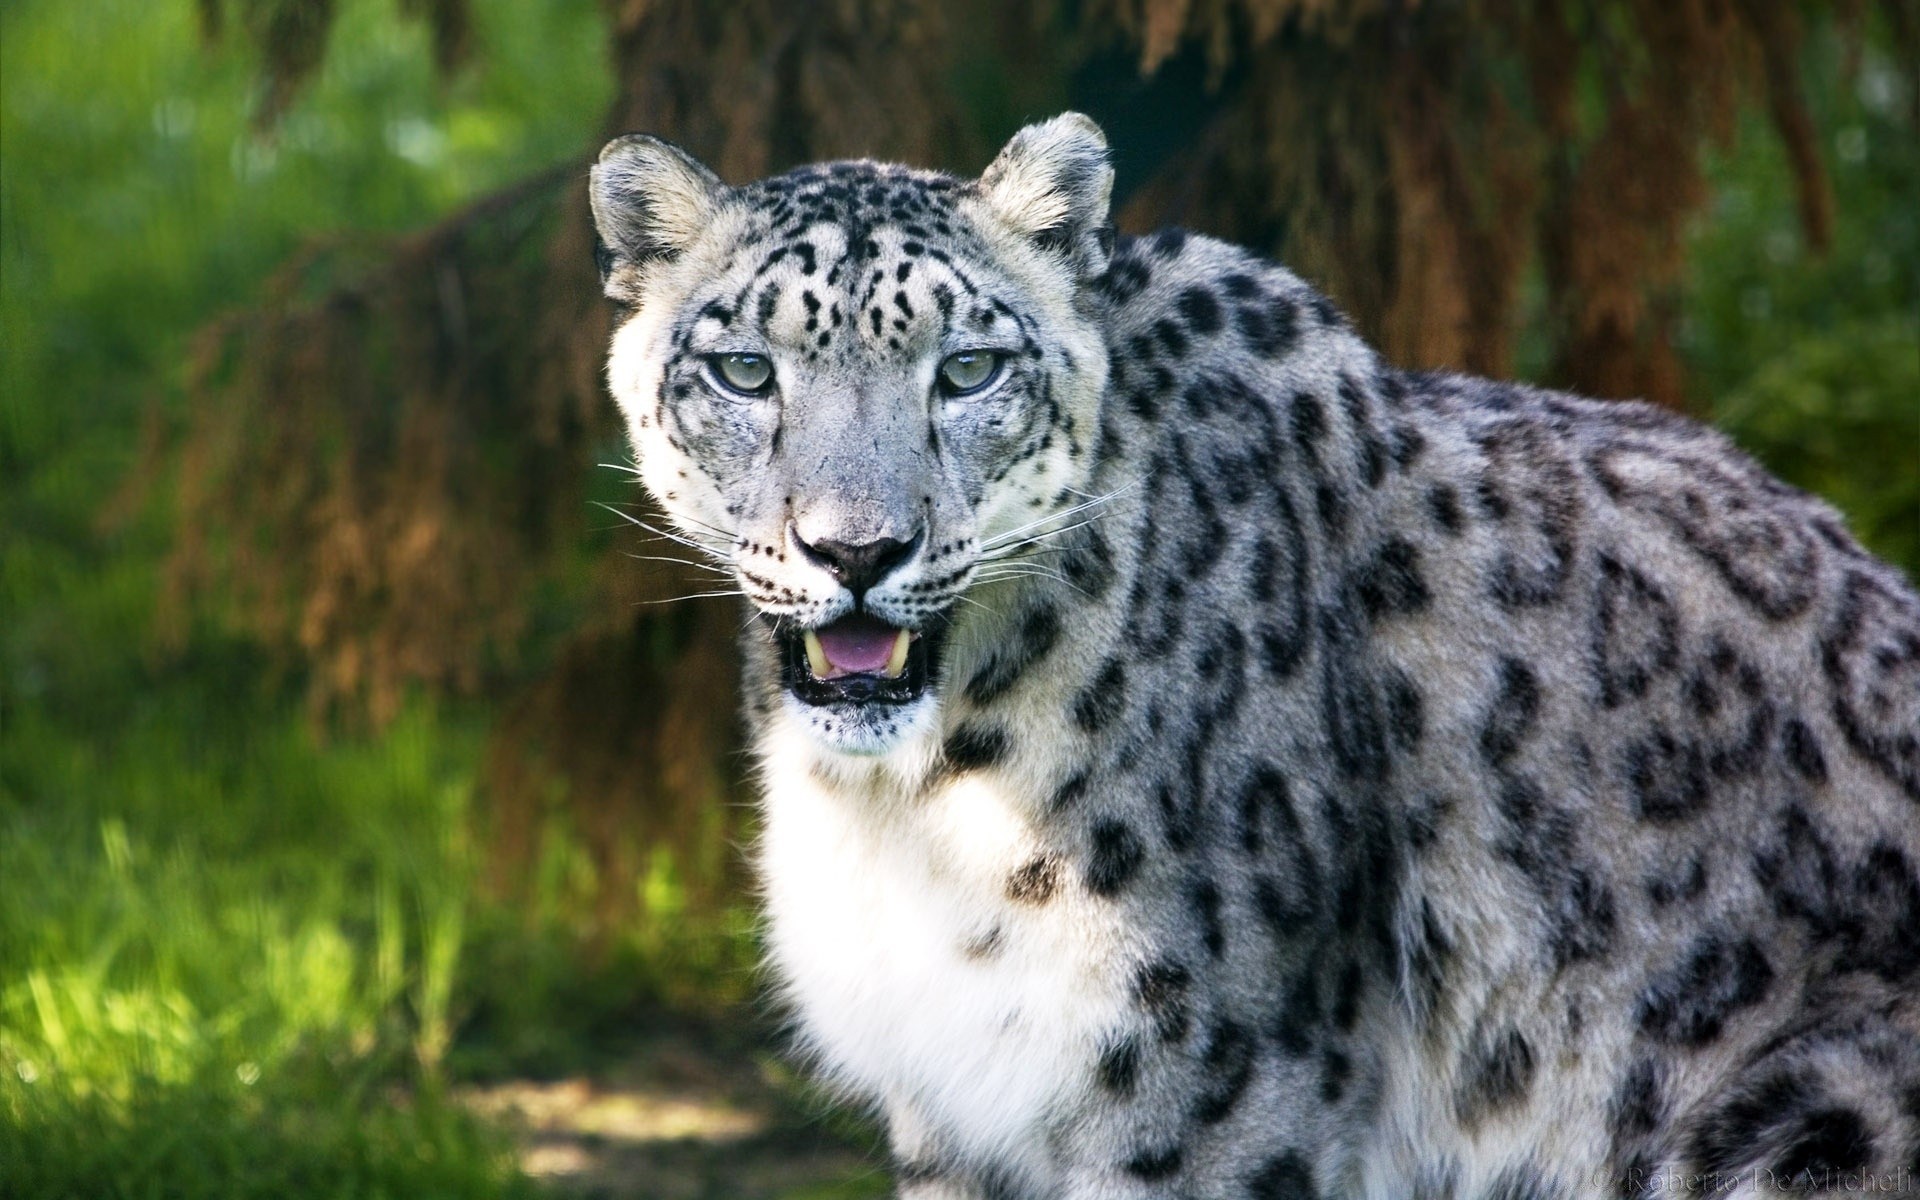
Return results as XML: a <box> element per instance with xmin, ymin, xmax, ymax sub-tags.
<box><xmin>175</xmin><ymin>0</ymin><xmax>1881</xmax><ymax>927</ymax></box>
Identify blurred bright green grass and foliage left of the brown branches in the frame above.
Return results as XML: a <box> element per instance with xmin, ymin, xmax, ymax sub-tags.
<box><xmin>0</xmin><ymin>0</ymin><xmax>637</xmax><ymax>1198</ymax></box>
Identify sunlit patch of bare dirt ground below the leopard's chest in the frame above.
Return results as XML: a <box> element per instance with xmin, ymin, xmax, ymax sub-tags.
<box><xmin>457</xmin><ymin>1025</ymin><xmax>889</xmax><ymax>1200</ymax></box>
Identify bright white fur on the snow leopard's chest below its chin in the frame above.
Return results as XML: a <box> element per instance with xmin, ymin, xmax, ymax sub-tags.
<box><xmin>760</xmin><ymin>721</ymin><xmax>1127</xmax><ymax>1171</ymax></box>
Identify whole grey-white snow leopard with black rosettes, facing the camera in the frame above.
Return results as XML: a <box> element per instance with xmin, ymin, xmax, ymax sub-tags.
<box><xmin>588</xmin><ymin>113</ymin><xmax>1920</xmax><ymax>1200</ymax></box>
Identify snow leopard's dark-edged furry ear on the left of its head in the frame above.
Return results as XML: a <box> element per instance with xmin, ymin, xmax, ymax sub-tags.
<box><xmin>588</xmin><ymin>132</ymin><xmax>728</xmax><ymax>303</ymax></box>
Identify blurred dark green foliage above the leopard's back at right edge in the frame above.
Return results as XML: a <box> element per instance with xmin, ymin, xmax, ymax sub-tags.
<box><xmin>1680</xmin><ymin>23</ymin><xmax>1920</xmax><ymax>580</ymax></box>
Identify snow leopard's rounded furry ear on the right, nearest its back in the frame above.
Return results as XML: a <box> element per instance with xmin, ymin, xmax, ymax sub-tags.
<box><xmin>979</xmin><ymin>113</ymin><xmax>1114</xmax><ymax>278</ymax></box>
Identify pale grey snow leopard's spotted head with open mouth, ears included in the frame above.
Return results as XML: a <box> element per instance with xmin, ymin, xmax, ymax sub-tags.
<box><xmin>591</xmin><ymin>113</ymin><xmax>1112</xmax><ymax>755</ymax></box>
